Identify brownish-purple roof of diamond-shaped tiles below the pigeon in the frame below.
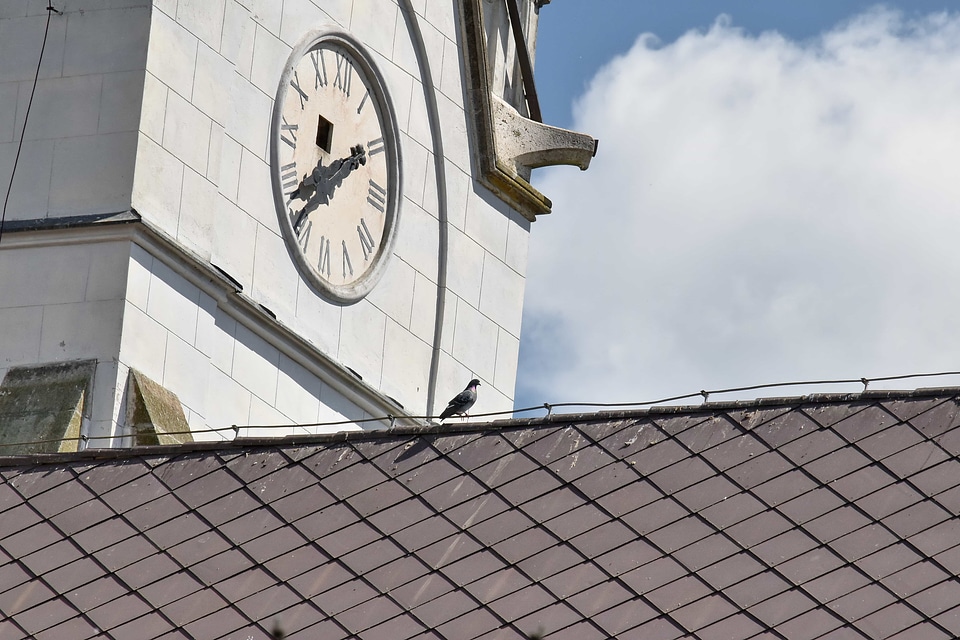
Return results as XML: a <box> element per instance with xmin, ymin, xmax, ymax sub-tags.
<box><xmin>0</xmin><ymin>389</ymin><xmax>960</xmax><ymax>640</ymax></box>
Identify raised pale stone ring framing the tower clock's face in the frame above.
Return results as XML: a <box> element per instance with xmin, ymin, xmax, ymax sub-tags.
<box><xmin>270</xmin><ymin>27</ymin><xmax>401</xmax><ymax>303</ymax></box>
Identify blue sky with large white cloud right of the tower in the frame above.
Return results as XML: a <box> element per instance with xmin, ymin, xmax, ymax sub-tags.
<box><xmin>515</xmin><ymin>0</ymin><xmax>960</xmax><ymax>415</ymax></box>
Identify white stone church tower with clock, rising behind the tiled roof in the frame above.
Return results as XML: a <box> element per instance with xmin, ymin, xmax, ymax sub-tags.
<box><xmin>0</xmin><ymin>0</ymin><xmax>595</xmax><ymax>453</ymax></box>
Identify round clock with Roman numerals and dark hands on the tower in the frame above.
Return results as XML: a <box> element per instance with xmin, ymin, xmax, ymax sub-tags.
<box><xmin>270</xmin><ymin>29</ymin><xmax>400</xmax><ymax>303</ymax></box>
